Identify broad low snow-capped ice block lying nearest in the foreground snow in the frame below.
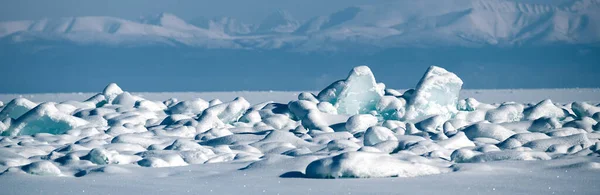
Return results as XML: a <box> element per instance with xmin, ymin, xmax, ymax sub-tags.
<box><xmin>306</xmin><ymin>152</ymin><xmax>450</xmax><ymax>178</ymax></box>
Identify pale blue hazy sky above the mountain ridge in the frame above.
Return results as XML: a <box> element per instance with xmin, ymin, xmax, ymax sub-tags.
<box><xmin>0</xmin><ymin>0</ymin><xmax>389</xmax><ymax>23</ymax></box>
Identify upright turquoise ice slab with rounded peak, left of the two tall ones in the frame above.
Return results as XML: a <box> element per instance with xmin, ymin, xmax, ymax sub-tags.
<box><xmin>318</xmin><ymin>66</ymin><xmax>385</xmax><ymax>115</ymax></box>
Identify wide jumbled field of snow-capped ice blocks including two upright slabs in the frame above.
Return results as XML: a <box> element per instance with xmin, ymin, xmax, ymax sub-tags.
<box><xmin>0</xmin><ymin>66</ymin><xmax>600</xmax><ymax>178</ymax></box>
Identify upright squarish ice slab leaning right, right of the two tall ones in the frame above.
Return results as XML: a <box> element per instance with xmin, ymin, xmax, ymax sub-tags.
<box><xmin>404</xmin><ymin>66</ymin><xmax>463</xmax><ymax>121</ymax></box>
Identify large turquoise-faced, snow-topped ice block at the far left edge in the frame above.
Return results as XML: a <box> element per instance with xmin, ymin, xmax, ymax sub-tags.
<box><xmin>2</xmin><ymin>103</ymin><xmax>88</xmax><ymax>136</ymax></box>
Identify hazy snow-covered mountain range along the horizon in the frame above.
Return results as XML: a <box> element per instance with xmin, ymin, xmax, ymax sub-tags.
<box><xmin>0</xmin><ymin>0</ymin><xmax>600</xmax><ymax>51</ymax></box>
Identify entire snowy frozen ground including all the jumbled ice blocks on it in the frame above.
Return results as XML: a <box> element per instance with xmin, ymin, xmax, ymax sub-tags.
<box><xmin>0</xmin><ymin>66</ymin><xmax>600</xmax><ymax>194</ymax></box>
